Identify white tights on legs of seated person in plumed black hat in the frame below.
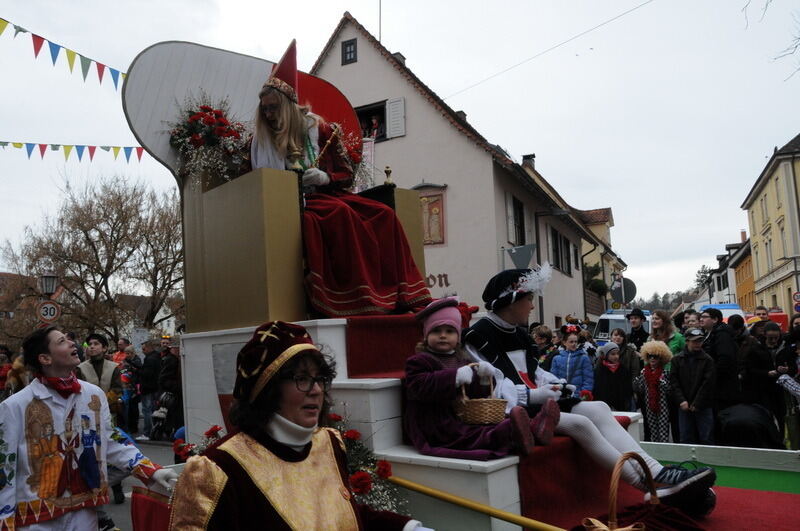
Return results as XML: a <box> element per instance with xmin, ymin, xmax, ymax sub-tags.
<box><xmin>555</xmin><ymin>402</ymin><xmax>663</xmax><ymax>491</ymax></box>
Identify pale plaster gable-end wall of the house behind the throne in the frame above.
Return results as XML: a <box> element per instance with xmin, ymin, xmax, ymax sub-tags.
<box><xmin>316</xmin><ymin>25</ymin><xmax>496</xmax><ymax>305</ymax></box>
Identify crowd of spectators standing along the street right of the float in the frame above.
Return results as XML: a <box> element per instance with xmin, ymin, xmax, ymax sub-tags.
<box><xmin>530</xmin><ymin>307</ymin><xmax>800</xmax><ymax>450</ymax></box>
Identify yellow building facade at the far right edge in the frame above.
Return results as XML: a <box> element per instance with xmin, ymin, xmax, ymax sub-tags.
<box><xmin>741</xmin><ymin>135</ymin><xmax>800</xmax><ymax>313</ymax></box>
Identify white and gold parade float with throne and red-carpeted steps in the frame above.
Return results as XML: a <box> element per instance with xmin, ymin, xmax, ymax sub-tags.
<box><xmin>123</xmin><ymin>42</ymin><xmax>800</xmax><ymax>530</ymax></box>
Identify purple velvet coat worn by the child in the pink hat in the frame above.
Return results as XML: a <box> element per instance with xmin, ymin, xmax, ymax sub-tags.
<box><xmin>403</xmin><ymin>352</ymin><xmax>511</xmax><ymax>461</ymax></box>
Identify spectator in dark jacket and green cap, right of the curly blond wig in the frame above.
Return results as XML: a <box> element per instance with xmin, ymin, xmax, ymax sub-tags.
<box><xmin>670</xmin><ymin>328</ymin><xmax>715</xmax><ymax>444</ymax></box>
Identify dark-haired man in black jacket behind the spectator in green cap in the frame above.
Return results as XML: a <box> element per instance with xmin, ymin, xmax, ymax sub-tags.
<box><xmin>700</xmin><ymin>308</ymin><xmax>742</xmax><ymax>411</ymax></box>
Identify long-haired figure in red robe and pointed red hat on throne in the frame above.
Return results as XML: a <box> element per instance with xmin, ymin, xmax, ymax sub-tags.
<box><xmin>251</xmin><ymin>42</ymin><xmax>430</xmax><ymax>317</ymax></box>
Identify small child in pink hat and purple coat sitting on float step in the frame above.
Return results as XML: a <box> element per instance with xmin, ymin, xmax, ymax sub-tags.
<box><xmin>403</xmin><ymin>297</ymin><xmax>552</xmax><ymax>460</ymax></box>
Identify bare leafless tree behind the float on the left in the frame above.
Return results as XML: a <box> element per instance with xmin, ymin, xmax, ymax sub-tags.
<box><xmin>3</xmin><ymin>177</ymin><xmax>183</xmax><ymax>337</ymax></box>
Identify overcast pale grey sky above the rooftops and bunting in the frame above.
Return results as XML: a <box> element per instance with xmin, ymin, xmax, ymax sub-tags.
<box><xmin>0</xmin><ymin>0</ymin><xmax>800</xmax><ymax>302</ymax></box>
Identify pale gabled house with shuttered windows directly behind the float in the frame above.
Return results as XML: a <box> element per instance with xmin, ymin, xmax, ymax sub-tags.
<box><xmin>311</xmin><ymin>13</ymin><xmax>612</xmax><ymax>326</ymax></box>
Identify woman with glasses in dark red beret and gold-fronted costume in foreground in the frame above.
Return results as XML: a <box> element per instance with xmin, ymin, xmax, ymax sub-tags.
<box><xmin>170</xmin><ymin>321</ymin><xmax>420</xmax><ymax>531</ymax></box>
